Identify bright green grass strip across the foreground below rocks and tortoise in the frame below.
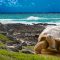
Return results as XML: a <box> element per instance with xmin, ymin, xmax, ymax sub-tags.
<box><xmin>0</xmin><ymin>50</ymin><xmax>60</xmax><ymax>60</ymax></box>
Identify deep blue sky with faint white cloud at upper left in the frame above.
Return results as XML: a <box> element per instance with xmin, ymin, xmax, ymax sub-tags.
<box><xmin>0</xmin><ymin>0</ymin><xmax>60</xmax><ymax>13</ymax></box>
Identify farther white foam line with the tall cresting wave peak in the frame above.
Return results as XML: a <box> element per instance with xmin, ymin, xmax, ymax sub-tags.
<box><xmin>0</xmin><ymin>16</ymin><xmax>60</xmax><ymax>21</ymax></box>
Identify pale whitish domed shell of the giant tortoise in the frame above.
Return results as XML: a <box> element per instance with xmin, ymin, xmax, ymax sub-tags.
<box><xmin>38</xmin><ymin>26</ymin><xmax>60</xmax><ymax>41</ymax></box>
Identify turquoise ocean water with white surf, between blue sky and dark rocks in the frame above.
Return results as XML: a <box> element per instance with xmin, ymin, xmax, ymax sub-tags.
<box><xmin>0</xmin><ymin>13</ymin><xmax>60</xmax><ymax>25</ymax></box>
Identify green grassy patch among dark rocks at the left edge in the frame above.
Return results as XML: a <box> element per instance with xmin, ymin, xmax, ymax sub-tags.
<box><xmin>0</xmin><ymin>34</ymin><xmax>13</xmax><ymax>49</ymax></box>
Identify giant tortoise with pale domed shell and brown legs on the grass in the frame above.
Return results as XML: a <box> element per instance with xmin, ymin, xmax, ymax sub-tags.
<box><xmin>34</xmin><ymin>26</ymin><xmax>60</xmax><ymax>54</ymax></box>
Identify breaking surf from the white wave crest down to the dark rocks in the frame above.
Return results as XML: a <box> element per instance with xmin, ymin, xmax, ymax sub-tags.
<box><xmin>0</xmin><ymin>16</ymin><xmax>60</xmax><ymax>24</ymax></box>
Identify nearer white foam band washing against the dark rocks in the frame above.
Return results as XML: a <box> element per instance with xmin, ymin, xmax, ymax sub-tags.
<box><xmin>0</xmin><ymin>19</ymin><xmax>60</xmax><ymax>25</ymax></box>
